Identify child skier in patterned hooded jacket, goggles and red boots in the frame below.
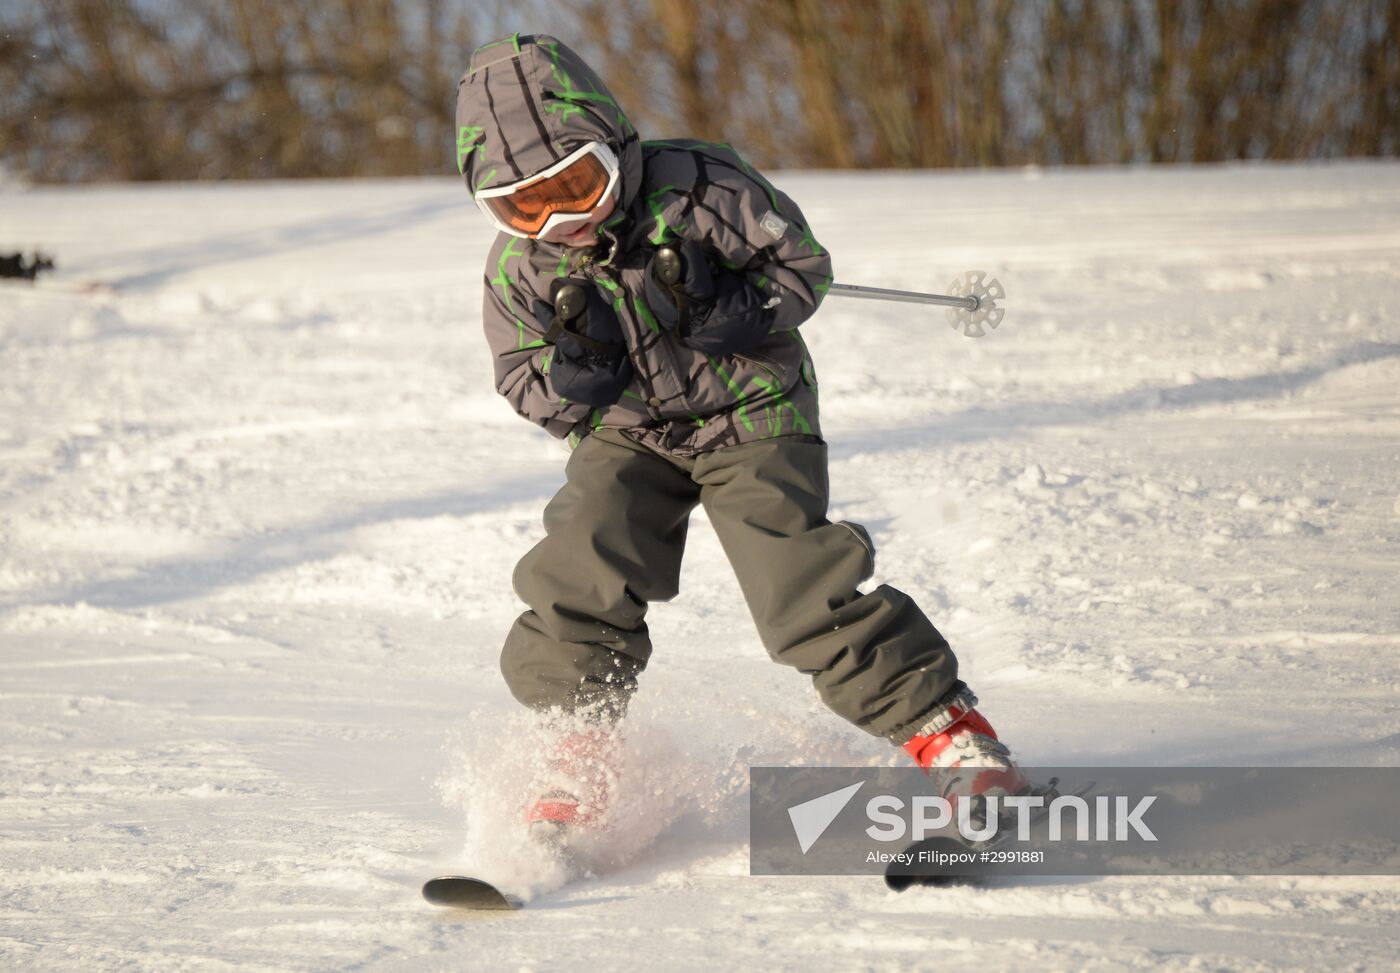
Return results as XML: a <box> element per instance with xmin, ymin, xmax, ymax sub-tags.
<box><xmin>456</xmin><ymin>35</ymin><xmax>1026</xmax><ymax>827</ymax></box>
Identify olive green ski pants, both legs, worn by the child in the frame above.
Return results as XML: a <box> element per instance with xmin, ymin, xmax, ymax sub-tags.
<box><xmin>501</xmin><ymin>427</ymin><xmax>962</xmax><ymax>743</ymax></box>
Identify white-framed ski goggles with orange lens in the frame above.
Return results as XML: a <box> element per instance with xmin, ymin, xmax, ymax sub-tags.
<box><xmin>473</xmin><ymin>141</ymin><xmax>619</xmax><ymax>238</ymax></box>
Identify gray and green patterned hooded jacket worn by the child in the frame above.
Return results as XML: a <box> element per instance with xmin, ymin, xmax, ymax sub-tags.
<box><xmin>456</xmin><ymin>35</ymin><xmax>832</xmax><ymax>455</ymax></box>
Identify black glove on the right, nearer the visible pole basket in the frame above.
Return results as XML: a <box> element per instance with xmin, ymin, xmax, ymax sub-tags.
<box><xmin>647</xmin><ymin>239</ymin><xmax>773</xmax><ymax>354</ymax></box>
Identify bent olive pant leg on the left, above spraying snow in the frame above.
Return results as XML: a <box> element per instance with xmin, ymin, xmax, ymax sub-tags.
<box><xmin>501</xmin><ymin>427</ymin><xmax>699</xmax><ymax>715</ymax></box>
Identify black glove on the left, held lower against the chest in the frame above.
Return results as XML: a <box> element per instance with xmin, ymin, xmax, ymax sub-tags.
<box><xmin>533</xmin><ymin>277</ymin><xmax>633</xmax><ymax>407</ymax></box>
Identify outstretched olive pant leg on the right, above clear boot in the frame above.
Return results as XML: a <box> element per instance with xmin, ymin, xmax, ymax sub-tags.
<box><xmin>694</xmin><ymin>437</ymin><xmax>960</xmax><ymax>743</ymax></box>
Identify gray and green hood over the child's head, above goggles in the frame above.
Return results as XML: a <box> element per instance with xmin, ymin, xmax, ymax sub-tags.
<box><xmin>456</xmin><ymin>34</ymin><xmax>641</xmax><ymax>218</ymax></box>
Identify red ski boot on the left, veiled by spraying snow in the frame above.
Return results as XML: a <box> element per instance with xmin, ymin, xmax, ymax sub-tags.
<box><xmin>525</xmin><ymin>728</ymin><xmax>619</xmax><ymax>840</ymax></box>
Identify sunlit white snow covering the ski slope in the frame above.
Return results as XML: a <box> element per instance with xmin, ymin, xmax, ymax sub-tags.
<box><xmin>0</xmin><ymin>162</ymin><xmax>1400</xmax><ymax>970</ymax></box>
